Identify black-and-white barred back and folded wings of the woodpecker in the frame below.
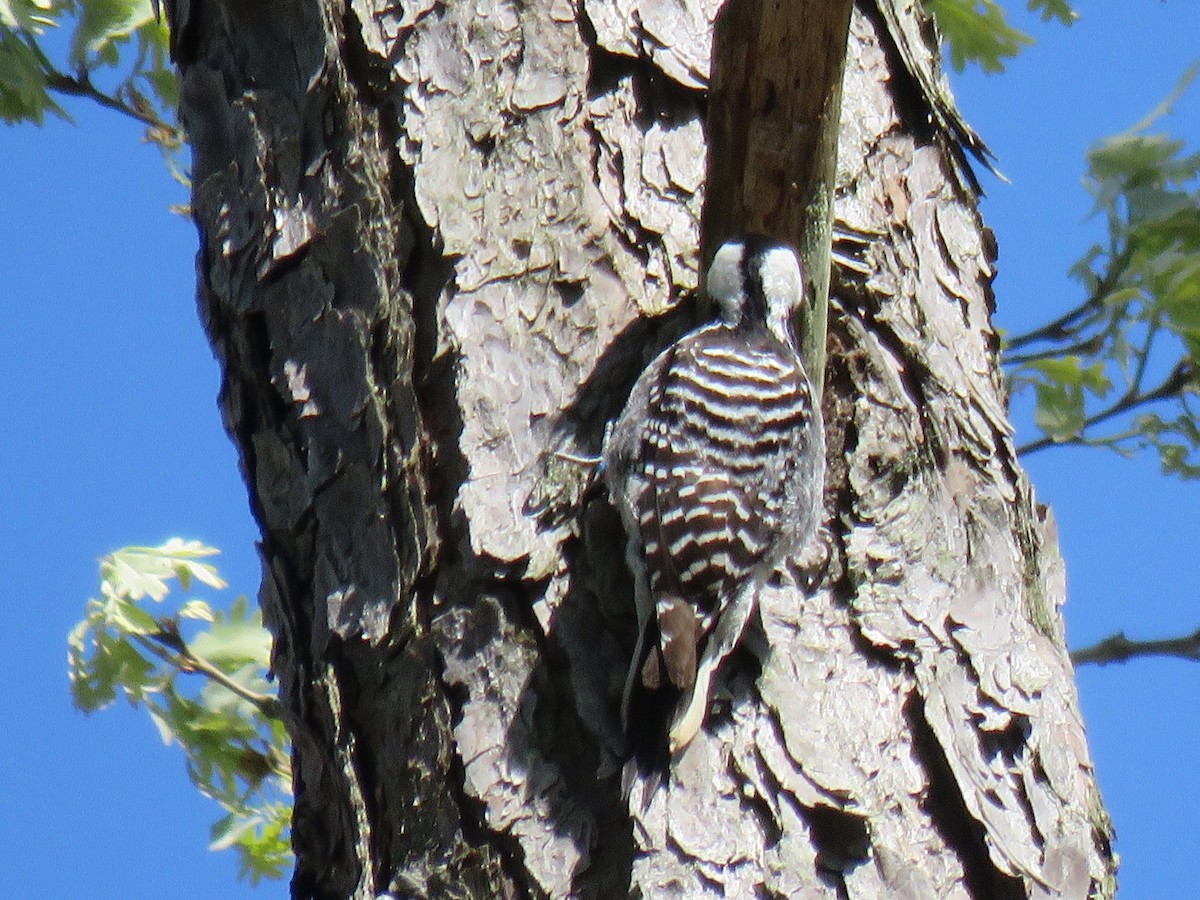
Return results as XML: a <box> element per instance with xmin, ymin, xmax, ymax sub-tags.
<box><xmin>629</xmin><ymin>325</ymin><xmax>814</xmax><ymax>688</ymax></box>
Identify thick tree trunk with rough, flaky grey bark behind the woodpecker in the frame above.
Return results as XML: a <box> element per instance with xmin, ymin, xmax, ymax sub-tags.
<box><xmin>170</xmin><ymin>0</ymin><xmax>1115</xmax><ymax>898</ymax></box>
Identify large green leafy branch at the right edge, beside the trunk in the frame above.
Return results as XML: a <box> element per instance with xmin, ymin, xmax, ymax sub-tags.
<box><xmin>1004</xmin><ymin>65</ymin><xmax>1200</xmax><ymax>478</ymax></box>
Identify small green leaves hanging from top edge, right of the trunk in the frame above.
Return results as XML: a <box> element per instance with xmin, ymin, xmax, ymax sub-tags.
<box><xmin>925</xmin><ymin>0</ymin><xmax>1079</xmax><ymax>72</ymax></box>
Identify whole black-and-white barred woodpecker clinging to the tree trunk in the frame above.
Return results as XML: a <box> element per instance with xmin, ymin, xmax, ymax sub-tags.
<box><xmin>602</xmin><ymin>235</ymin><xmax>824</xmax><ymax>755</ymax></box>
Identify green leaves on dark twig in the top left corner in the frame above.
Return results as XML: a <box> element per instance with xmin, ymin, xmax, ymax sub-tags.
<box><xmin>0</xmin><ymin>0</ymin><xmax>184</xmax><ymax>179</ymax></box>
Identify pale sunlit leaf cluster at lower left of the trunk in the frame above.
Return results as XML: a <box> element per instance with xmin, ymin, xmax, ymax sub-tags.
<box><xmin>67</xmin><ymin>539</ymin><xmax>292</xmax><ymax>883</ymax></box>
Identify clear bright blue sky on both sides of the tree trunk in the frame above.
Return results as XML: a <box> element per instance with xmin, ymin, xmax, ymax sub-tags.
<box><xmin>0</xmin><ymin>0</ymin><xmax>1200</xmax><ymax>898</ymax></box>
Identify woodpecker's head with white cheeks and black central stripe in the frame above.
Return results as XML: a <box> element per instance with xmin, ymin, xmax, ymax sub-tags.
<box><xmin>708</xmin><ymin>234</ymin><xmax>804</xmax><ymax>344</ymax></box>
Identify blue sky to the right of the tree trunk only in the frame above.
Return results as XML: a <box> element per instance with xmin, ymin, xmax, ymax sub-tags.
<box><xmin>955</xmin><ymin>0</ymin><xmax>1200</xmax><ymax>900</ymax></box>
